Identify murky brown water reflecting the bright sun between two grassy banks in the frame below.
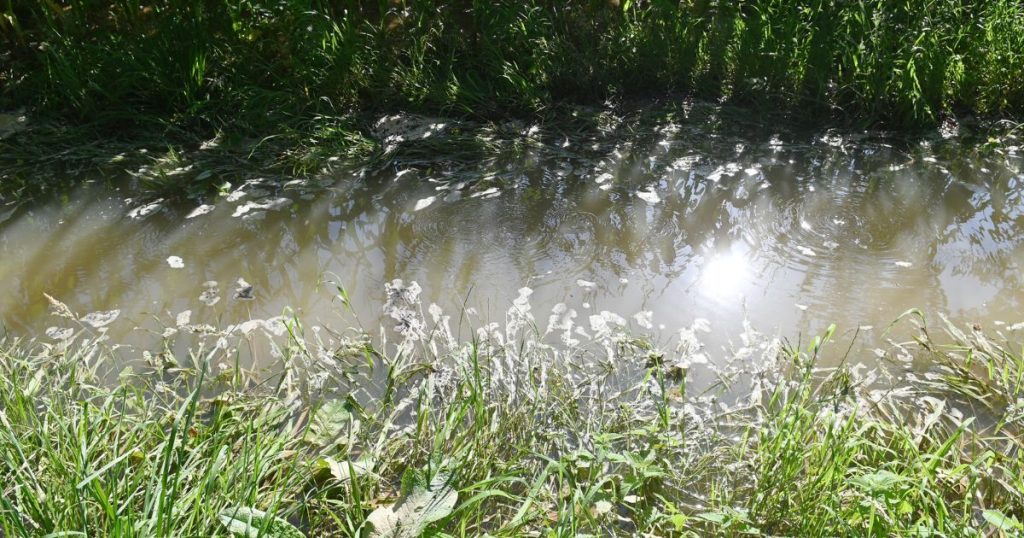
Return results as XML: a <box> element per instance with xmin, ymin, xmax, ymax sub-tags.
<box><xmin>0</xmin><ymin>107</ymin><xmax>1024</xmax><ymax>370</ymax></box>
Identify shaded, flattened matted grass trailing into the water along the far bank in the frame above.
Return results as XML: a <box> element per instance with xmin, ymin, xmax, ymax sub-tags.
<box><xmin>0</xmin><ymin>94</ymin><xmax>1016</xmax><ymax>212</ymax></box>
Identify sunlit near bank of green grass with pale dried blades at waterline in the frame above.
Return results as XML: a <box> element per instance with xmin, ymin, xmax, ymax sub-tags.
<box><xmin>0</xmin><ymin>288</ymin><xmax>1024</xmax><ymax>537</ymax></box>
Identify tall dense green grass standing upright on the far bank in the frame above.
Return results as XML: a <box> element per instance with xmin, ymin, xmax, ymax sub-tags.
<box><xmin>0</xmin><ymin>0</ymin><xmax>1024</xmax><ymax>129</ymax></box>
